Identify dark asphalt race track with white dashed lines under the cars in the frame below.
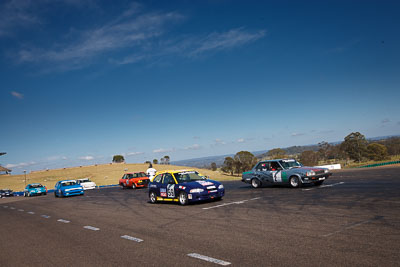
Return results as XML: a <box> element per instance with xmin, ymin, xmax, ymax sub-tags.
<box><xmin>0</xmin><ymin>167</ymin><xmax>400</xmax><ymax>266</ymax></box>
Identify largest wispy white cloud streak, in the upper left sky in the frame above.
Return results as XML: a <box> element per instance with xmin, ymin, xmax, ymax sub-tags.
<box><xmin>19</xmin><ymin>13</ymin><xmax>182</xmax><ymax>69</ymax></box>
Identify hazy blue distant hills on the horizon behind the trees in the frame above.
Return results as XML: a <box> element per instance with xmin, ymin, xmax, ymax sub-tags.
<box><xmin>171</xmin><ymin>135</ymin><xmax>400</xmax><ymax>168</ymax></box>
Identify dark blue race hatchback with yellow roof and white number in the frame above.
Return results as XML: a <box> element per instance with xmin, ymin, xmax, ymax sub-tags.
<box><xmin>149</xmin><ymin>170</ymin><xmax>225</xmax><ymax>205</ymax></box>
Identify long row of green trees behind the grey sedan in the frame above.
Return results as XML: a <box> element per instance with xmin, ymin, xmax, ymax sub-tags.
<box><xmin>210</xmin><ymin>132</ymin><xmax>400</xmax><ymax>175</ymax></box>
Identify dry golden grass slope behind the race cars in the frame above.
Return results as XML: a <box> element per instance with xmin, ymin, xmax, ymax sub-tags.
<box><xmin>0</xmin><ymin>163</ymin><xmax>241</xmax><ymax>191</ymax></box>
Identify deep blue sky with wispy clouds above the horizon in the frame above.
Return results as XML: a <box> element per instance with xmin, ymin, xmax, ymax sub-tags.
<box><xmin>0</xmin><ymin>0</ymin><xmax>400</xmax><ymax>174</ymax></box>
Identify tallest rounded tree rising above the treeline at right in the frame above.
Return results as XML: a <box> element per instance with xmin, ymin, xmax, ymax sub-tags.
<box><xmin>342</xmin><ymin>132</ymin><xmax>368</xmax><ymax>162</ymax></box>
